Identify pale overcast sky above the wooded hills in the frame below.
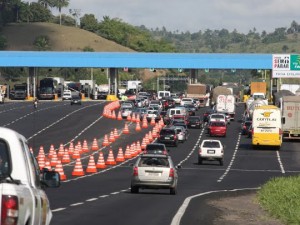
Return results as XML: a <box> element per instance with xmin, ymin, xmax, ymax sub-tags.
<box><xmin>54</xmin><ymin>0</ymin><xmax>300</xmax><ymax>33</ymax></box>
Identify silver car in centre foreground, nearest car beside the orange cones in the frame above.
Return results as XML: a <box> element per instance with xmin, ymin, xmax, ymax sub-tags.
<box><xmin>131</xmin><ymin>154</ymin><xmax>178</xmax><ymax>195</ymax></box>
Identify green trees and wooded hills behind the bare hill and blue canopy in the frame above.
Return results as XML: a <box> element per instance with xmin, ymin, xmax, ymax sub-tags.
<box><xmin>0</xmin><ymin>0</ymin><xmax>300</xmax><ymax>53</ymax></box>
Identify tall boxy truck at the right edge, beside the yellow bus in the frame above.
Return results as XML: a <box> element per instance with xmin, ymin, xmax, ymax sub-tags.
<box><xmin>280</xmin><ymin>96</ymin><xmax>300</xmax><ymax>140</ymax></box>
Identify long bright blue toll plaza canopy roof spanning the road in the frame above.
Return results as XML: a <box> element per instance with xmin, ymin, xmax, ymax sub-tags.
<box><xmin>0</xmin><ymin>51</ymin><xmax>272</xmax><ymax>69</ymax></box>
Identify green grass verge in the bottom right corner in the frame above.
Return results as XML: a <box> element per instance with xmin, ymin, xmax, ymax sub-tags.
<box><xmin>258</xmin><ymin>176</ymin><xmax>300</xmax><ymax>225</ymax></box>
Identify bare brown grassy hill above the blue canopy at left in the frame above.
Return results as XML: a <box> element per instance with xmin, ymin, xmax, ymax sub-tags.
<box><xmin>0</xmin><ymin>23</ymin><xmax>133</xmax><ymax>52</ymax></box>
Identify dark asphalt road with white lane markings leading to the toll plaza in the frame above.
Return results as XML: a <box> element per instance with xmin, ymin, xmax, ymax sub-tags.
<box><xmin>0</xmin><ymin>101</ymin><xmax>300</xmax><ymax>225</ymax></box>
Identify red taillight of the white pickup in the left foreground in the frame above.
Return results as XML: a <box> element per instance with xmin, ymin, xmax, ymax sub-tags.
<box><xmin>1</xmin><ymin>195</ymin><xmax>19</xmax><ymax>225</ymax></box>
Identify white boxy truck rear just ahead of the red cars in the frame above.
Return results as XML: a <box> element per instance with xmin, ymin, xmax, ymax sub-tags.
<box><xmin>216</xmin><ymin>95</ymin><xmax>235</xmax><ymax>120</ymax></box>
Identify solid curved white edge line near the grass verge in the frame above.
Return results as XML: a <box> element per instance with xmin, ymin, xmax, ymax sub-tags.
<box><xmin>170</xmin><ymin>188</ymin><xmax>259</xmax><ymax>225</ymax></box>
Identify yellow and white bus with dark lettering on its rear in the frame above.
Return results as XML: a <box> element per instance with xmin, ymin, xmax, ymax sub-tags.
<box><xmin>252</xmin><ymin>105</ymin><xmax>283</xmax><ymax>149</ymax></box>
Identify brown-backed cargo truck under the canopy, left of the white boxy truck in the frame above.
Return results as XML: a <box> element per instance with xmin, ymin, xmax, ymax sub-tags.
<box><xmin>186</xmin><ymin>84</ymin><xmax>208</xmax><ymax>107</ymax></box>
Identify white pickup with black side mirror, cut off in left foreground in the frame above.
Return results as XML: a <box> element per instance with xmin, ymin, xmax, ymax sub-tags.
<box><xmin>0</xmin><ymin>127</ymin><xmax>60</xmax><ymax>225</ymax></box>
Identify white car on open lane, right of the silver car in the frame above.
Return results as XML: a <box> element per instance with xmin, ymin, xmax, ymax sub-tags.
<box><xmin>198</xmin><ymin>139</ymin><xmax>224</xmax><ymax>166</ymax></box>
